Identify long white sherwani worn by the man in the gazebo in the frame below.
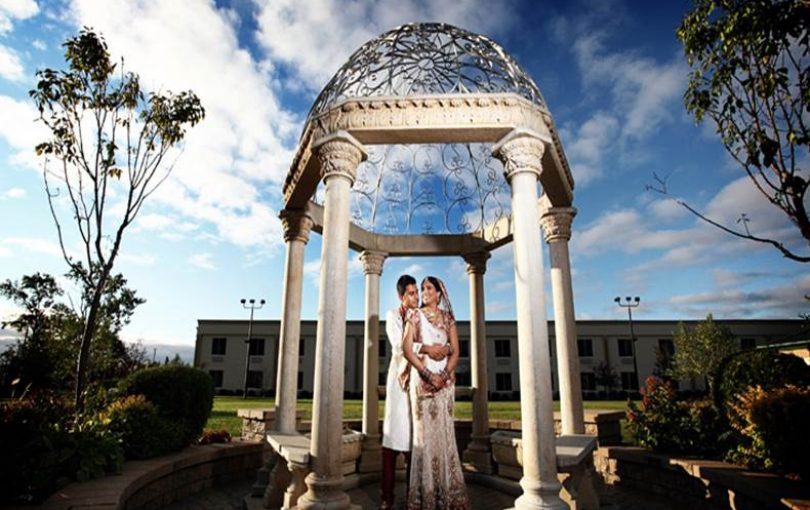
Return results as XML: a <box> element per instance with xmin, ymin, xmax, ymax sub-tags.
<box><xmin>383</xmin><ymin>307</ymin><xmax>419</xmax><ymax>452</ymax></box>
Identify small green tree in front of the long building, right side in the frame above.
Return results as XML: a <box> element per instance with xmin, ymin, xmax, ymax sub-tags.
<box><xmin>670</xmin><ymin>314</ymin><xmax>737</xmax><ymax>388</ymax></box>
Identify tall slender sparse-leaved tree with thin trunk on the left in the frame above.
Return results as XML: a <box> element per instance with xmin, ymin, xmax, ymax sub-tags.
<box><xmin>30</xmin><ymin>28</ymin><xmax>205</xmax><ymax>411</ymax></box>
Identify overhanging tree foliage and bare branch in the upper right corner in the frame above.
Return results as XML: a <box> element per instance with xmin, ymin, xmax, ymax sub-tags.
<box><xmin>676</xmin><ymin>0</ymin><xmax>810</xmax><ymax>262</ymax></box>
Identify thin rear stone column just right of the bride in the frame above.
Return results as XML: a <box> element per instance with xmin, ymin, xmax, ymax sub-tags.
<box><xmin>462</xmin><ymin>251</ymin><xmax>492</xmax><ymax>474</ymax></box>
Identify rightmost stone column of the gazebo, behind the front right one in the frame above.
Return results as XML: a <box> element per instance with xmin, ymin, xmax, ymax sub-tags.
<box><xmin>540</xmin><ymin>207</ymin><xmax>585</xmax><ymax>434</ymax></box>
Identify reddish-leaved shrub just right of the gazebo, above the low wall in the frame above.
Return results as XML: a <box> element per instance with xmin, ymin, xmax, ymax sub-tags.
<box><xmin>627</xmin><ymin>376</ymin><xmax>720</xmax><ymax>454</ymax></box>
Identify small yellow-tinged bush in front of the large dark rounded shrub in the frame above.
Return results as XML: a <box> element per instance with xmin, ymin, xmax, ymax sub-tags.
<box><xmin>102</xmin><ymin>395</ymin><xmax>180</xmax><ymax>459</ymax></box>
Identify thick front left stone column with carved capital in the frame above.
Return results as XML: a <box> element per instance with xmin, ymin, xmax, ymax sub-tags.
<box><xmin>298</xmin><ymin>131</ymin><xmax>367</xmax><ymax>510</ymax></box>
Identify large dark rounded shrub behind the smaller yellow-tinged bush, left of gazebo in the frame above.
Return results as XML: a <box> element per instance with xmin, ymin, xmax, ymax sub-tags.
<box><xmin>120</xmin><ymin>364</ymin><xmax>214</xmax><ymax>449</ymax></box>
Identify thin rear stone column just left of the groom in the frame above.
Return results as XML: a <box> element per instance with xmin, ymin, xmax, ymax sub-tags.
<box><xmin>359</xmin><ymin>250</ymin><xmax>386</xmax><ymax>473</ymax></box>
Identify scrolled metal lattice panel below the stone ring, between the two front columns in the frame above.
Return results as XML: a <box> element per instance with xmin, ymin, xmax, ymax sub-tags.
<box><xmin>313</xmin><ymin>143</ymin><xmax>511</xmax><ymax>235</ymax></box>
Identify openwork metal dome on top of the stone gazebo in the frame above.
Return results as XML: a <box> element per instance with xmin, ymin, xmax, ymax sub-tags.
<box><xmin>309</xmin><ymin>23</ymin><xmax>545</xmax><ymax>118</ymax></box>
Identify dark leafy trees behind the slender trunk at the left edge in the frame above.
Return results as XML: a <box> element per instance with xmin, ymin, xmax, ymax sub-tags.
<box><xmin>0</xmin><ymin>273</ymin><xmax>146</xmax><ymax>396</ymax></box>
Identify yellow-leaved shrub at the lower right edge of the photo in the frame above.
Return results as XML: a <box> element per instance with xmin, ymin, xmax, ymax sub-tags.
<box><xmin>729</xmin><ymin>386</ymin><xmax>810</xmax><ymax>480</ymax></box>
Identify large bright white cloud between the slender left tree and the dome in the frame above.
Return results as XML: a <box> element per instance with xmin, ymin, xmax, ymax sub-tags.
<box><xmin>66</xmin><ymin>0</ymin><xmax>300</xmax><ymax>253</ymax></box>
